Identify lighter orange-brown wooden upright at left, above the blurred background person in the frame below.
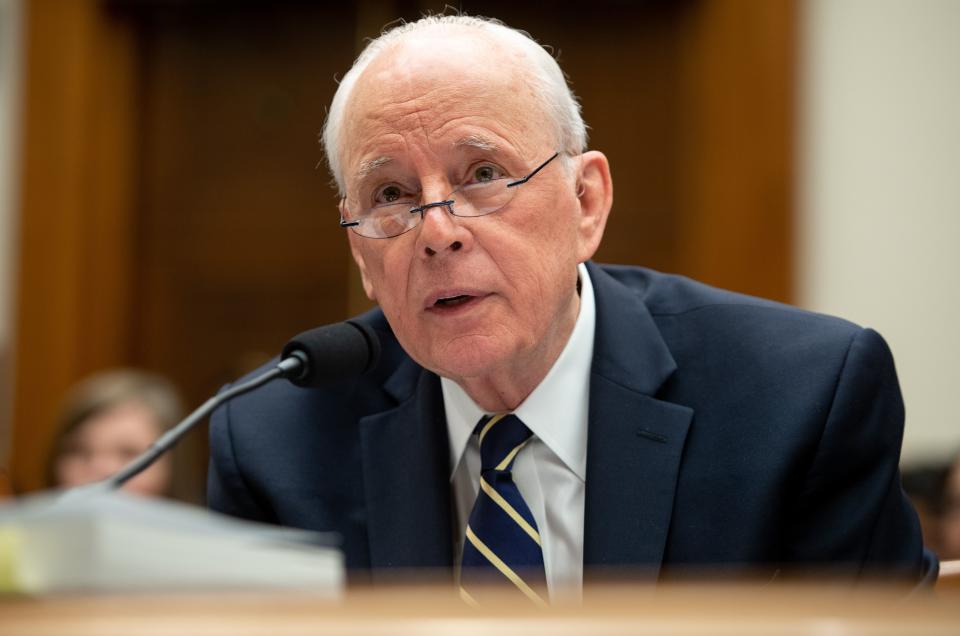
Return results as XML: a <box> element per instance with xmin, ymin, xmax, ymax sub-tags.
<box><xmin>11</xmin><ymin>0</ymin><xmax>136</xmax><ymax>489</ymax></box>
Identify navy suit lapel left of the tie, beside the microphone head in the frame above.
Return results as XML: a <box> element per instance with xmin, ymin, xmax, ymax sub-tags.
<box><xmin>360</xmin><ymin>361</ymin><xmax>453</xmax><ymax>579</ymax></box>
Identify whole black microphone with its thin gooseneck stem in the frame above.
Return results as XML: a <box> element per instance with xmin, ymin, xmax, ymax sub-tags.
<box><xmin>71</xmin><ymin>320</ymin><xmax>380</xmax><ymax>493</ymax></box>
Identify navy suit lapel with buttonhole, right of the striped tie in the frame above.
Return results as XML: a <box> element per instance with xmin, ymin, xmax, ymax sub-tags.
<box><xmin>584</xmin><ymin>263</ymin><xmax>693</xmax><ymax>579</ymax></box>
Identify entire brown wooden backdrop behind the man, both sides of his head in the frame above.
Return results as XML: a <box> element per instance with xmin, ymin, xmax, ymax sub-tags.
<box><xmin>8</xmin><ymin>0</ymin><xmax>797</xmax><ymax>501</ymax></box>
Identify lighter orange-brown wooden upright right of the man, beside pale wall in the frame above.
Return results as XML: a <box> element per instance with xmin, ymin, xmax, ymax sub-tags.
<box><xmin>674</xmin><ymin>0</ymin><xmax>796</xmax><ymax>301</ymax></box>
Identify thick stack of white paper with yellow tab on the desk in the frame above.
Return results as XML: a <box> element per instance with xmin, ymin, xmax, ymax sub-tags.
<box><xmin>0</xmin><ymin>492</ymin><xmax>344</xmax><ymax>598</ymax></box>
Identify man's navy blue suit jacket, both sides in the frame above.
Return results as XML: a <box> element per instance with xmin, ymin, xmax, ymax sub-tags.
<box><xmin>208</xmin><ymin>263</ymin><xmax>936</xmax><ymax>579</ymax></box>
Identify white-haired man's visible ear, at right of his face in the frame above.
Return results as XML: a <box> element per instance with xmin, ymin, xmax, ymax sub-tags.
<box><xmin>576</xmin><ymin>150</ymin><xmax>613</xmax><ymax>263</ymax></box>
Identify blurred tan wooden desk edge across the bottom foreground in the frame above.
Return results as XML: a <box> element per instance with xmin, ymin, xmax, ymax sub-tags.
<box><xmin>0</xmin><ymin>584</ymin><xmax>960</xmax><ymax>636</ymax></box>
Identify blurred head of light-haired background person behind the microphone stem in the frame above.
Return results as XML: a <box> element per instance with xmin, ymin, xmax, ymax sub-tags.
<box><xmin>46</xmin><ymin>369</ymin><xmax>183</xmax><ymax>496</ymax></box>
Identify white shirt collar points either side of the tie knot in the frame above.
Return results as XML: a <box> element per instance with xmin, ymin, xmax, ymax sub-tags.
<box><xmin>440</xmin><ymin>263</ymin><xmax>596</xmax><ymax>480</ymax></box>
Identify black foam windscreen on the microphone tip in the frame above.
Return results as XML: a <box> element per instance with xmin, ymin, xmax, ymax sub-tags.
<box><xmin>283</xmin><ymin>321</ymin><xmax>380</xmax><ymax>387</ymax></box>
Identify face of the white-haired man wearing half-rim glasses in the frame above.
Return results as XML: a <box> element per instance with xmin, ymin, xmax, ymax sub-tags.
<box><xmin>341</xmin><ymin>37</ymin><xmax>602</xmax><ymax>396</ymax></box>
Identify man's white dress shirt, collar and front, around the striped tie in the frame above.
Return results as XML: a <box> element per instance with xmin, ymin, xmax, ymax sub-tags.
<box><xmin>440</xmin><ymin>264</ymin><xmax>596</xmax><ymax>601</ymax></box>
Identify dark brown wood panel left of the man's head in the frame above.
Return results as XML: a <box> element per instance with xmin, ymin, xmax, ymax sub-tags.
<box><xmin>134</xmin><ymin>3</ymin><xmax>354</xmax><ymax>502</ymax></box>
